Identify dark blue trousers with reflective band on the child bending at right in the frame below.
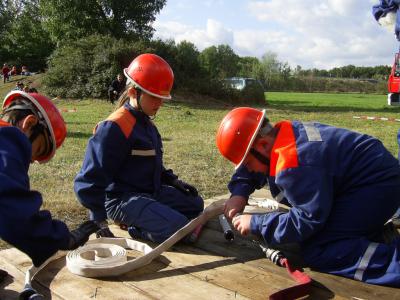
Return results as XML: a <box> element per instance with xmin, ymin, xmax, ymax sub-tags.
<box><xmin>302</xmin><ymin>184</ymin><xmax>400</xmax><ymax>287</ymax></box>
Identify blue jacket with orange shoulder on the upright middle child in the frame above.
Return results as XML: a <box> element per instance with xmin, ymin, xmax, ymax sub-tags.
<box><xmin>74</xmin><ymin>103</ymin><xmax>177</xmax><ymax>221</ymax></box>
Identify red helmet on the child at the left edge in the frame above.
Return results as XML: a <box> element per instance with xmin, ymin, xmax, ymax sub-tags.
<box><xmin>3</xmin><ymin>91</ymin><xmax>67</xmax><ymax>163</ymax></box>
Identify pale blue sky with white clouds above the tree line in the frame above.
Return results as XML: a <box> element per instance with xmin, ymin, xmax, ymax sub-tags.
<box><xmin>153</xmin><ymin>0</ymin><xmax>399</xmax><ymax>69</ymax></box>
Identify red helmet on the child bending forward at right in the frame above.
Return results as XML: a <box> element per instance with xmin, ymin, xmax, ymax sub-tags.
<box><xmin>216</xmin><ymin>107</ymin><xmax>265</xmax><ymax>169</ymax></box>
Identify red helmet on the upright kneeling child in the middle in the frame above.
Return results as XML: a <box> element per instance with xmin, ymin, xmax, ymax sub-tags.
<box><xmin>124</xmin><ymin>53</ymin><xmax>174</xmax><ymax>100</ymax></box>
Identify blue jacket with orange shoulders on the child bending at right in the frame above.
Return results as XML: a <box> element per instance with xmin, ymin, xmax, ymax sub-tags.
<box><xmin>228</xmin><ymin>121</ymin><xmax>400</xmax><ymax>244</ymax></box>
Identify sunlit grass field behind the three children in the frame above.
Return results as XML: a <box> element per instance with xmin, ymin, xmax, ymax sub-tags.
<box><xmin>0</xmin><ymin>77</ymin><xmax>400</xmax><ymax>247</ymax></box>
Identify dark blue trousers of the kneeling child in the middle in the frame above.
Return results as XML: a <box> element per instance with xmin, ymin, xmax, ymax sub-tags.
<box><xmin>106</xmin><ymin>185</ymin><xmax>204</xmax><ymax>243</ymax></box>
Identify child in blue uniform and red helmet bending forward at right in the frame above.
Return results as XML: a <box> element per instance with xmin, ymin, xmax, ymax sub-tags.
<box><xmin>217</xmin><ymin>108</ymin><xmax>400</xmax><ymax>287</ymax></box>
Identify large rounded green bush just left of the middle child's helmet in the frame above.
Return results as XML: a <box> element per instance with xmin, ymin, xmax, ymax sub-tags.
<box><xmin>43</xmin><ymin>35</ymin><xmax>148</xmax><ymax>98</ymax></box>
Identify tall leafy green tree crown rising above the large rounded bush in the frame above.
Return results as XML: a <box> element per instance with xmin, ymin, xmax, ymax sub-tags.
<box><xmin>39</xmin><ymin>0</ymin><xmax>166</xmax><ymax>43</ymax></box>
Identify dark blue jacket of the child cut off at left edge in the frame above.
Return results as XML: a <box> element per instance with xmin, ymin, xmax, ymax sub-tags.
<box><xmin>0</xmin><ymin>120</ymin><xmax>70</xmax><ymax>266</ymax></box>
